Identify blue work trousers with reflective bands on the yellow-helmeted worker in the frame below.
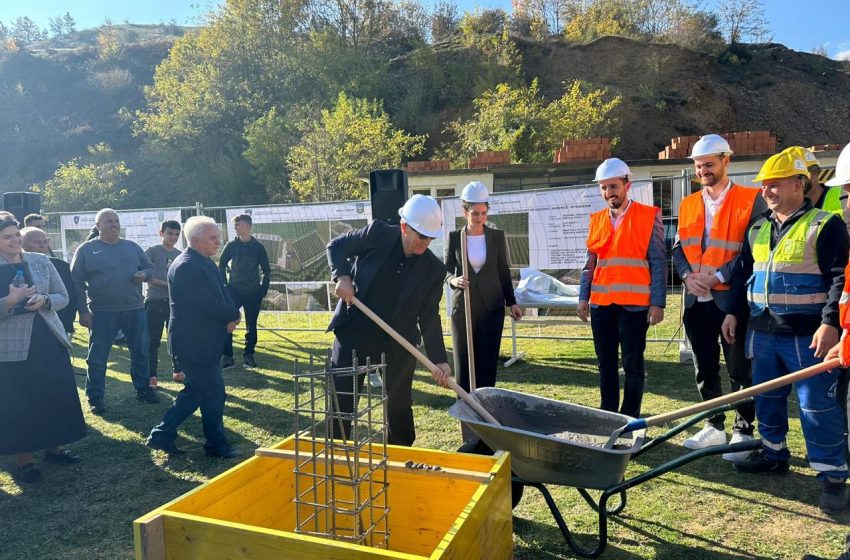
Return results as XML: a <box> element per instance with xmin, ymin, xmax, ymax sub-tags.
<box><xmin>747</xmin><ymin>330</ymin><xmax>847</xmax><ymax>479</ymax></box>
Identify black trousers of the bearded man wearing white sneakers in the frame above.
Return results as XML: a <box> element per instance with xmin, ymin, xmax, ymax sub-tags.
<box><xmin>683</xmin><ymin>301</ymin><xmax>756</xmax><ymax>435</ymax></box>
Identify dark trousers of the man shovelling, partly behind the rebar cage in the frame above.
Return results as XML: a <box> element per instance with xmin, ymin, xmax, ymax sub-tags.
<box><xmin>331</xmin><ymin>339</ymin><xmax>416</xmax><ymax>446</ymax></box>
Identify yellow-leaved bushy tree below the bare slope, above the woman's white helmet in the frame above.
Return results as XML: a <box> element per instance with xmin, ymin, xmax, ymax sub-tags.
<box><xmin>441</xmin><ymin>79</ymin><xmax>621</xmax><ymax>163</ymax></box>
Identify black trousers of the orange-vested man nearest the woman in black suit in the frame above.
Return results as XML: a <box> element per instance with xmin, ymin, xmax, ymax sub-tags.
<box><xmin>590</xmin><ymin>304</ymin><xmax>649</xmax><ymax>418</ymax></box>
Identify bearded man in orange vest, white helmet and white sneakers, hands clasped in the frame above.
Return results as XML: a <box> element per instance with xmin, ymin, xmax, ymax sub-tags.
<box><xmin>673</xmin><ymin>134</ymin><xmax>766</xmax><ymax>461</ymax></box>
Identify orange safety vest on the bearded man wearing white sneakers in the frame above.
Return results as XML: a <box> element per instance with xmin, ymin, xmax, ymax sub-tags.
<box><xmin>679</xmin><ymin>184</ymin><xmax>759</xmax><ymax>290</ymax></box>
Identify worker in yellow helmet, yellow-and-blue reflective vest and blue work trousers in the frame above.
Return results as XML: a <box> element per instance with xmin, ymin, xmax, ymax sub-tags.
<box><xmin>723</xmin><ymin>152</ymin><xmax>850</xmax><ymax>514</ymax></box>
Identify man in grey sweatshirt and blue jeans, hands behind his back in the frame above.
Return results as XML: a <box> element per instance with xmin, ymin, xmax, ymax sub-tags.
<box><xmin>71</xmin><ymin>208</ymin><xmax>159</xmax><ymax>414</ymax></box>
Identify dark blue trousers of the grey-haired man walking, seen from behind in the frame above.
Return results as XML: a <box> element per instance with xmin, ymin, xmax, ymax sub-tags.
<box><xmin>150</xmin><ymin>360</ymin><xmax>227</xmax><ymax>451</ymax></box>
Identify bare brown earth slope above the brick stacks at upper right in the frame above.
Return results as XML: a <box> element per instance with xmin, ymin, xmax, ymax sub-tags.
<box><xmin>524</xmin><ymin>37</ymin><xmax>850</xmax><ymax>158</ymax></box>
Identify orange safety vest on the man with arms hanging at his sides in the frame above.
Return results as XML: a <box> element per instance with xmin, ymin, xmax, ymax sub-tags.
<box><xmin>587</xmin><ymin>200</ymin><xmax>660</xmax><ymax>306</ymax></box>
